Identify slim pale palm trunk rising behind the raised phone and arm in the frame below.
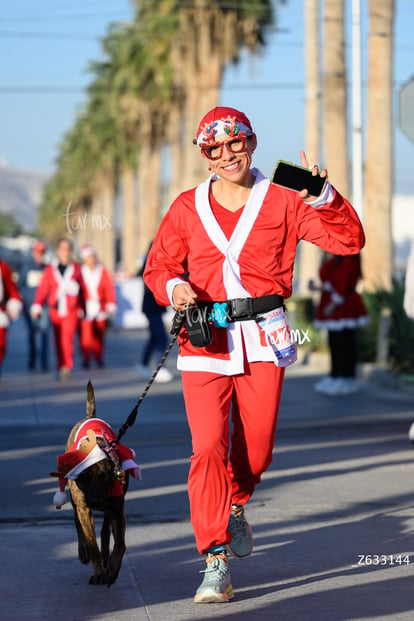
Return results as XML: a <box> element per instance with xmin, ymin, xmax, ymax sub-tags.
<box><xmin>297</xmin><ymin>0</ymin><xmax>321</xmax><ymax>296</ymax></box>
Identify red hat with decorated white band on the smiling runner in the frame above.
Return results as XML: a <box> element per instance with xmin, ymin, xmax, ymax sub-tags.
<box><xmin>195</xmin><ymin>106</ymin><xmax>253</xmax><ymax>145</ymax></box>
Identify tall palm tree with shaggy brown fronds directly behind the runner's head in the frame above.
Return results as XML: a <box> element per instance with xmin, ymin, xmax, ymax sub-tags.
<box><xmin>174</xmin><ymin>0</ymin><xmax>273</xmax><ymax>187</ymax></box>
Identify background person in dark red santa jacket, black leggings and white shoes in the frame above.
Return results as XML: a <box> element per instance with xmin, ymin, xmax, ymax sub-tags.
<box><xmin>309</xmin><ymin>254</ymin><xmax>369</xmax><ymax>396</ymax></box>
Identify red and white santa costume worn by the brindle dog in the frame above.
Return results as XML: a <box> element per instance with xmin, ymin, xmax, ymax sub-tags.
<box><xmin>50</xmin><ymin>418</ymin><xmax>141</xmax><ymax>509</ymax></box>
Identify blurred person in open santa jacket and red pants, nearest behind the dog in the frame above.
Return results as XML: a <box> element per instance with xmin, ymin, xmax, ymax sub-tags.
<box><xmin>30</xmin><ymin>238</ymin><xmax>85</xmax><ymax>381</ymax></box>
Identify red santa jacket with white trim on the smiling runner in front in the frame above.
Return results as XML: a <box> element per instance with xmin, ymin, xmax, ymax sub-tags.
<box><xmin>144</xmin><ymin>169</ymin><xmax>365</xmax><ymax>375</ymax></box>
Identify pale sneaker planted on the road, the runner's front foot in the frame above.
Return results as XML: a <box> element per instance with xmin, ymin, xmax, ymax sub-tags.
<box><xmin>194</xmin><ymin>552</ymin><xmax>234</xmax><ymax>604</ymax></box>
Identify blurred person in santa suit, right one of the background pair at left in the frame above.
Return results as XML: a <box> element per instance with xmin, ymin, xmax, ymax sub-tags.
<box><xmin>79</xmin><ymin>246</ymin><xmax>116</xmax><ymax>369</ymax></box>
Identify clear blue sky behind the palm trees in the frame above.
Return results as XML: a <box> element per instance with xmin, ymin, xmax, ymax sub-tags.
<box><xmin>0</xmin><ymin>0</ymin><xmax>414</xmax><ymax>194</ymax></box>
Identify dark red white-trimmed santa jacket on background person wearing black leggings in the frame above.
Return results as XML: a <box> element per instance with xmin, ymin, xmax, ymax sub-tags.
<box><xmin>315</xmin><ymin>255</ymin><xmax>369</xmax><ymax>330</ymax></box>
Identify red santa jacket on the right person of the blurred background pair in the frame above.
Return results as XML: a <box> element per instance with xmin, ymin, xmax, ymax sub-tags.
<box><xmin>81</xmin><ymin>263</ymin><xmax>116</xmax><ymax>320</ymax></box>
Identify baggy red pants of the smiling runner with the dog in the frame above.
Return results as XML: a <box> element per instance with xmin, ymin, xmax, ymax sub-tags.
<box><xmin>182</xmin><ymin>361</ymin><xmax>284</xmax><ymax>554</ymax></box>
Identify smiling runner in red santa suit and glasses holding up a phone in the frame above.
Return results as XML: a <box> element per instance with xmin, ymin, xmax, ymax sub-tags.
<box><xmin>144</xmin><ymin>107</ymin><xmax>364</xmax><ymax>603</ymax></box>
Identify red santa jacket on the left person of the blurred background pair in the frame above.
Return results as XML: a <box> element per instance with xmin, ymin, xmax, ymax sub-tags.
<box><xmin>31</xmin><ymin>260</ymin><xmax>85</xmax><ymax>319</ymax></box>
